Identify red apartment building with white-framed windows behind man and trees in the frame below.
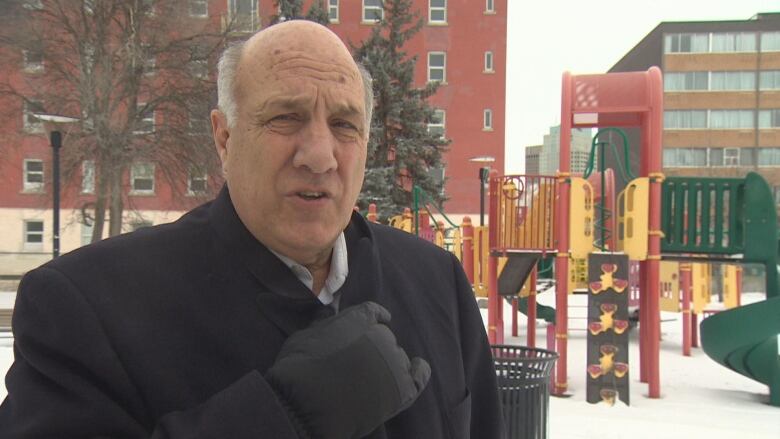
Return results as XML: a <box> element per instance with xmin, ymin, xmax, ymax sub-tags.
<box><xmin>0</xmin><ymin>0</ymin><xmax>508</xmax><ymax>275</ymax></box>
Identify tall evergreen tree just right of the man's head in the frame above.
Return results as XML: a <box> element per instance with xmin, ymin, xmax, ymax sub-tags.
<box><xmin>353</xmin><ymin>0</ymin><xmax>449</xmax><ymax>218</ymax></box>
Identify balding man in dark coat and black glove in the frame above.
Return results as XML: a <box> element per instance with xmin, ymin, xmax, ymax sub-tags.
<box><xmin>0</xmin><ymin>21</ymin><xmax>501</xmax><ymax>439</ymax></box>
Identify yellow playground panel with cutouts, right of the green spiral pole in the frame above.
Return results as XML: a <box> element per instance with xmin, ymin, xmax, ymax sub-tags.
<box><xmin>622</xmin><ymin>177</ymin><xmax>650</xmax><ymax>261</ymax></box>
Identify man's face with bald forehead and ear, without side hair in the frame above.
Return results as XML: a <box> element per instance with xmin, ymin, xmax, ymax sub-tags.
<box><xmin>212</xmin><ymin>23</ymin><xmax>368</xmax><ymax>264</ymax></box>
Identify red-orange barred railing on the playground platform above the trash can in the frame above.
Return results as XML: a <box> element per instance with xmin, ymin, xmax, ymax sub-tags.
<box><xmin>490</xmin><ymin>175</ymin><xmax>557</xmax><ymax>253</ymax></box>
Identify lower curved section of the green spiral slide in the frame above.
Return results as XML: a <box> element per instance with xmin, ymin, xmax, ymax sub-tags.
<box><xmin>701</xmin><ymin>297</ymin><xmax>780</xmax><ymax>407</ymax></box>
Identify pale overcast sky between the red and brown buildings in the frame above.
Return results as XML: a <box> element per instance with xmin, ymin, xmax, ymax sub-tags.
<box><xmin>506</xmin><ymin>0</ymin><xmax>780</xmax><ymax>174</ymax></box>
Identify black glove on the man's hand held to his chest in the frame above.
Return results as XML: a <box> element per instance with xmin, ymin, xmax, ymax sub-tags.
<box><xmin>266</xmin><ymin>302</ymin><xmax>431</xmax><ymax>439</ymax></box>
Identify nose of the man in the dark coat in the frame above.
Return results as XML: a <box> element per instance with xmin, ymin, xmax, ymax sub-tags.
<box><xmin>293</xmin><ymin>120</ymin><xmax>338</xmax><ymax>174</ymax></box>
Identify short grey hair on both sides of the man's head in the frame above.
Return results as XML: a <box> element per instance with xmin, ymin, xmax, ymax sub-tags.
<box><xmin>217</xmin><ymin>41</ymin><xmax>374</xmax><ymax>134</ymax></box>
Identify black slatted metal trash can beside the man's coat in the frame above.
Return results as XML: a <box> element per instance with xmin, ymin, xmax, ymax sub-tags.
<box><xmin>491</xmin><ymin>345</ymin><xmax>558</xmax><ymax>439</ymax></box>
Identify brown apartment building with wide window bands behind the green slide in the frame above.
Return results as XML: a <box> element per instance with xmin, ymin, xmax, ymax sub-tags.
<box><xmin>610</xmin><ymin>13</ymin><xmax>780</xmax><ymax>203</ymax></box>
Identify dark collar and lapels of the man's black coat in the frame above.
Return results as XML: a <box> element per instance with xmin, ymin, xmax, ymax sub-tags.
<box><xmin>209</xmin><ymin>185</ymin><xmax>381</xmax><ymax>335</ymax></box>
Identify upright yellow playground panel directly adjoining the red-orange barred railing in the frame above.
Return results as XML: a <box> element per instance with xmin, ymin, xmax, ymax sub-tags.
<box><xmin>569</xmin><ymin>177</ymin><xmax>593</xmax><ymax>259</ymax></box>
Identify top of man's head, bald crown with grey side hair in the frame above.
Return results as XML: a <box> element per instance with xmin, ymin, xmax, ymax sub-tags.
<box><xmin>217</xmin><ymin>20</ymin><xmax>374</xmax><ymax>126</ymax></box>
